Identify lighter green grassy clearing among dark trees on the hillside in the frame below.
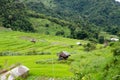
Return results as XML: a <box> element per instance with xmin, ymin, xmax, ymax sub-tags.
<box><xmin>30</xmin><ymin>18</ymin><xmax>70</xmax><ymax>37</ymax></box>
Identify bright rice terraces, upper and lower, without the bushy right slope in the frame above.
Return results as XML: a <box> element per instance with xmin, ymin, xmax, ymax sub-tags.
<box><xmin>0</xmin><ymin>28</ymin><xmax>86</xmax><ymax>77</ymax></box>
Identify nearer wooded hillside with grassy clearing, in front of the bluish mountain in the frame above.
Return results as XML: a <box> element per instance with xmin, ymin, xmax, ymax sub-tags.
<box><xmin>0</xmin><ymin>0</ymin><xmax>99</xmax><ymax>41</ymax></box>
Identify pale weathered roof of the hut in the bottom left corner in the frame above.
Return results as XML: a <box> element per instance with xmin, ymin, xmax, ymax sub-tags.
<box><xmin>0</xmin><ymin>65</ymin><xmax>29</xmax><ymax>80</ymax></box>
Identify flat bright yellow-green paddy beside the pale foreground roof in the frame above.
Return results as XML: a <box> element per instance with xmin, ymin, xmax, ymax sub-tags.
<box><xmin>0</xmin><ymin>55</ymin><xmax>73</xmax><ymax>77</ymax></box>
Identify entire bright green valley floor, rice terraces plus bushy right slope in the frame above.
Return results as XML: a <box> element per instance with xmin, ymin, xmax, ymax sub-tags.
<box><xmin>0</xmin><ymin>27</ymin><xmax>119</xmax><ymax>80</ymax></box>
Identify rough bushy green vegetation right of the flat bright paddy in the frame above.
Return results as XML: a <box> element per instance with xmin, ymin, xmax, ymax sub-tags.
<box><xmin>72</xmin><ymin>49</ymin><xmax>116</xmax><ymax>80</ymax></box>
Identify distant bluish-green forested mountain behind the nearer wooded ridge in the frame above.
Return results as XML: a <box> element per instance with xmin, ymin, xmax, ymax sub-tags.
<box><xmin>23</xmin><ymin>0</ymin><xmax>120</xmax><ymax>27</ymax></box>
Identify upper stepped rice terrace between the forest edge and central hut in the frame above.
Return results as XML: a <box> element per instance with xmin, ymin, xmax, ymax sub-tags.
<box><xmin>0</xmin><ymin>31</ymin><xmax>86</xmax><ymax>54</ymax></box>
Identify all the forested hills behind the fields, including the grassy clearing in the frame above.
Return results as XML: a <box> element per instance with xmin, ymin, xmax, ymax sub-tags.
<box><xmin>0</xmin><ymin>0</ymin><xmax>120</xmax><ymax>41</ymax></box>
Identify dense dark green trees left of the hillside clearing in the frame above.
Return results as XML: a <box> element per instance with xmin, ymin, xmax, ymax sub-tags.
<box><xmin>0</xmin><ymin>0</ymin><xmax>34</xmax><ymax>31</ymax></box>
